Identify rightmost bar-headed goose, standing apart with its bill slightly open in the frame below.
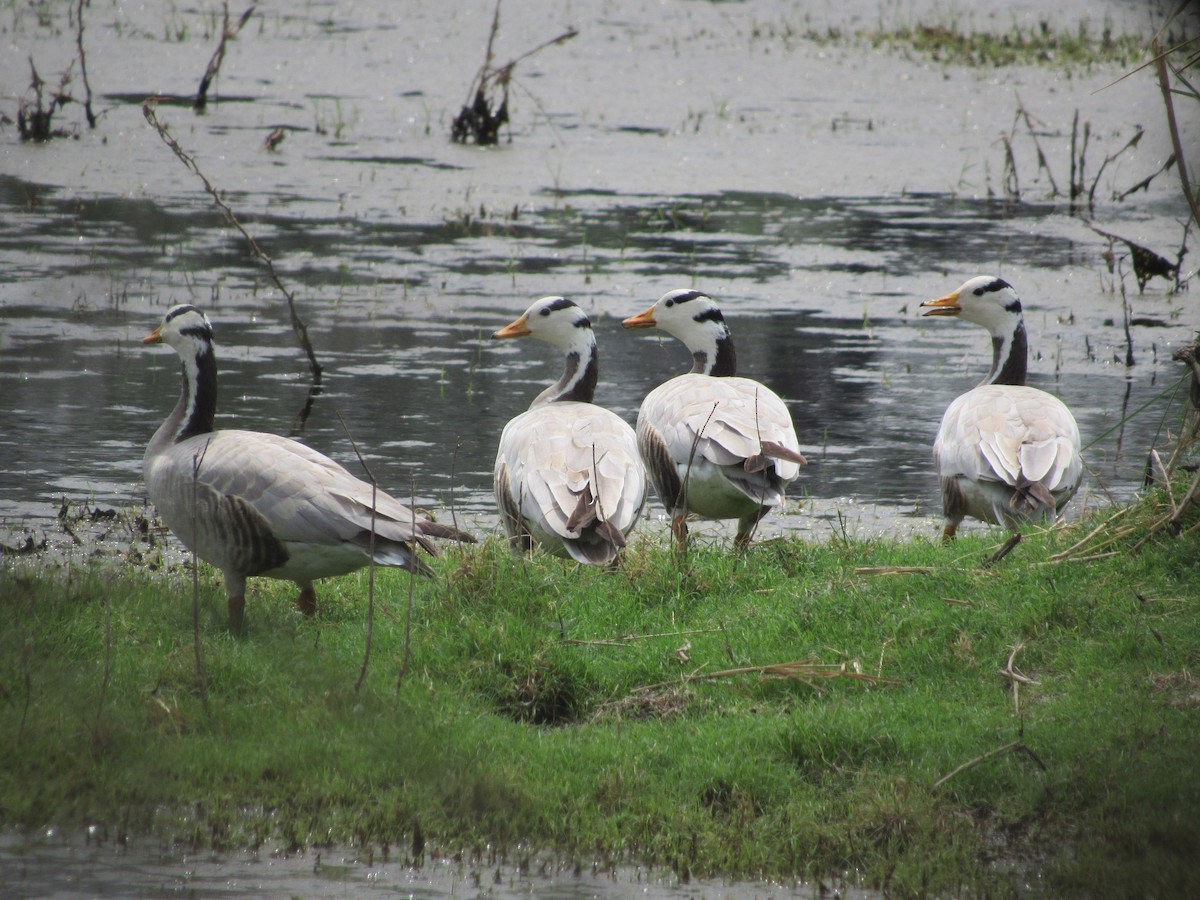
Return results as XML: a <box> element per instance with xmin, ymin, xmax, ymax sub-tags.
<box><xmin>922</xmin><ymin>275</ymin><xmax>1084</xmax><ymax>540</ymax></box>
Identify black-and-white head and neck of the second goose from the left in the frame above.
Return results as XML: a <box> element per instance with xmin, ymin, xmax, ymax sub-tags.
<box><xmin>492</xmin><ymin>296</ymin><xmax>600</xmax><ymax>406</ymax></box>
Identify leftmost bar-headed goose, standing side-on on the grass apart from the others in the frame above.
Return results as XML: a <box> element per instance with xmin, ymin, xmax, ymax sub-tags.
<box><xmin>142</xmin><ymin>305</ymin><xmax>473</xmax><ymax>631</ymax></box>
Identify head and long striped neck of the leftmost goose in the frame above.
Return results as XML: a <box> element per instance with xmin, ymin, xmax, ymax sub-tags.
<box><xmin>142</xmin><ymin>304</ymin><xmax>217</xmax><ymax>448</ymax></box>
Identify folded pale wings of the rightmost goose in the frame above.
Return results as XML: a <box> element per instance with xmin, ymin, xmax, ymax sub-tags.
<box><xmin>934</xmin><ymin>385</ymin><xmax>1084</xmax><ymax>491</ymax></box>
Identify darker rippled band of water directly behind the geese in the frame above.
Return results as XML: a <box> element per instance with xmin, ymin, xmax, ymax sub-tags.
<box><xmin>0</xmin><ymin>169</ymin><xmax>1180</xmax><ymax>549</ymax></box>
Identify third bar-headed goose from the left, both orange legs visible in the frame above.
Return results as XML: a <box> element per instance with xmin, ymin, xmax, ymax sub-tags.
<box><xmin>622</xmin><ymin>290</ymin><xmax>805</xmax><ymax>550</ymax></box>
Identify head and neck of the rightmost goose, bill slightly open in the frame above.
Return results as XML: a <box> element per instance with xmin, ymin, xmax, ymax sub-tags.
<box><xmin>920</xmin><ymin>275</ymin><xmax>1028</xmax><ymax>385</ymax></box>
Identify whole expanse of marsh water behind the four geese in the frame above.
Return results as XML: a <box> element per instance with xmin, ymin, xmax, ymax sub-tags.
<box><xmin>0</xmin><ymin>0</ymin><xmax>1200</xmax><ymax>895</ymax></box>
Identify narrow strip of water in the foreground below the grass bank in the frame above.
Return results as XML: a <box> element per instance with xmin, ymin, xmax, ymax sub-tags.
<box><xmin>0</xmin><ymin>829</ymin><xmax>880</xmax><ymax>900</ymax></box>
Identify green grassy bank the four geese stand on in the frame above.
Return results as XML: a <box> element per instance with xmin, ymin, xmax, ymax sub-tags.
<box><xmin>0</xmin><ymin>496</ymin><xmax>1200</xmax><ymax>895</ymax></box>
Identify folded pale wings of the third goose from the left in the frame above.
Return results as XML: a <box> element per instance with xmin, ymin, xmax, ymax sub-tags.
<box><xmin>638</xmin><ymin>373</ymin><xmax>804</xmax><ymax>482</ymax></box>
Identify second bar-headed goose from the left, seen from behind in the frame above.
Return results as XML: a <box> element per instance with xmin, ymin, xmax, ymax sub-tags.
<box><xmin>492</xmin><ymin>296</ymin><xmax>646</xmax><ymax>565</ymax></box>
